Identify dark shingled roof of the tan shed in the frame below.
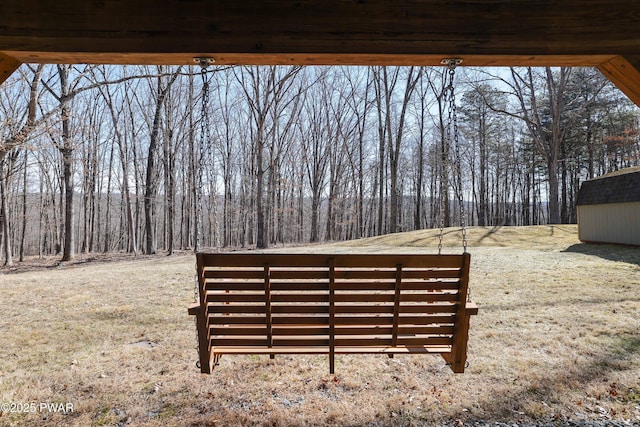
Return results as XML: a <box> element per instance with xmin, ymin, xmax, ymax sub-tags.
<box><xmin>577</xmin><ymin>167</ymin><xmax>640</xmax><ymax>206</ymax></box>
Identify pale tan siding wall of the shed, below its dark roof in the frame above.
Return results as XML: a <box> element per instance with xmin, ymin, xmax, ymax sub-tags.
<box><xmin>578</xmin><ymin>202</ymin><xmax>640</xmax><ymax>245</ymax></box>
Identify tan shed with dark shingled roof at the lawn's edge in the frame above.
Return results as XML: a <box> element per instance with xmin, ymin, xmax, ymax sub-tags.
<box><xmin>577</xmin><ymin>167</ymin><xmax>640</xmax><ymax>246</ymax></box>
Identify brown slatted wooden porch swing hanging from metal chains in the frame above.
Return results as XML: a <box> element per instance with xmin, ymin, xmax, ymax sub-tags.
<box><xmin>189</xmin><ymin>60</ymin><xmax>478</xmax><ymax>374</ymax></box>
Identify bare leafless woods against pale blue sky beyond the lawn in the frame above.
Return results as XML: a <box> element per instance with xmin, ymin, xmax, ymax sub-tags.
<box><xmin>0</xmin><ymin>65</ymin><xmax>640</xmax><ymax>264</ymax></box>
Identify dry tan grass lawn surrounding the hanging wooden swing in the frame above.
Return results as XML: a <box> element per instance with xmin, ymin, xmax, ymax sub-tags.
<box><xmin>0</xmin><ymin>226</ymin><xmax>640</xmax><ymax>426</ymax></box>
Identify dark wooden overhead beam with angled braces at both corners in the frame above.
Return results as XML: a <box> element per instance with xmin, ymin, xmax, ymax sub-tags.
<box><xmin>0</xmin><ymin>0</ymin><xmax>640</xmax><ymax>105</ymax></box>
